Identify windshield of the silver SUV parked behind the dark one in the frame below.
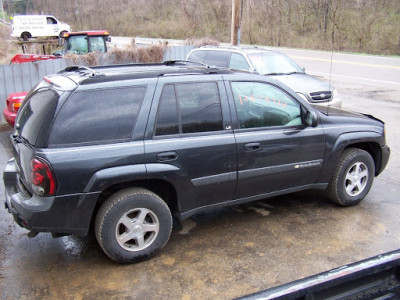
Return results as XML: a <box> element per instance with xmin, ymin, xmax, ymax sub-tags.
<box><xmin>248</xmin><ymin>52</ymin><xmax>304</xmax><ymax>75</ymax></box>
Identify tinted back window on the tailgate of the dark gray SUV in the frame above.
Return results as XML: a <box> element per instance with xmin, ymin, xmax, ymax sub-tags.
<box><xmin>15</xmin><ymin>89</ymin><xmax>59</xmax><ymax>147</ymax></box>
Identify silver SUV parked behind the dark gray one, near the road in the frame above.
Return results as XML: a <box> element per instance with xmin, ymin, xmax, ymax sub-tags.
<box><xmin>186</xmin><ymin>46</ymin><xmax>342</xmax><ymax>108</ymax></box>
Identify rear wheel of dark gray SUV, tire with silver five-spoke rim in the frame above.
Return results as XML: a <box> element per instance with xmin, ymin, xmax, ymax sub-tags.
<box><xmin>95</xmin><ymin>188</ymin><xmax>172</xmax><ymax>264</ymax></box>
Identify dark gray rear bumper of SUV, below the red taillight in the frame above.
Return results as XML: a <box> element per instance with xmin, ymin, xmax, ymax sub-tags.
<box><xmin>3</xmin><ymin>159</ymin><xmax>99</xmax><ymax>236</ymax></box>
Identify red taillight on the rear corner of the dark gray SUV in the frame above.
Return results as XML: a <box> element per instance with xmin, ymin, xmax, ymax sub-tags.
<box><xmin>31</xmin><ymin>158</ymin><xmax>56</xmax><ymax>197</ymax></box>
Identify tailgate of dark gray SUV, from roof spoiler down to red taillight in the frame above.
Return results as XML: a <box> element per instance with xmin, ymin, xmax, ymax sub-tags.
<box><xmin>11</xmin><ymin>75</ymin><xmax>77</xmax><ymax>196</ymax></box>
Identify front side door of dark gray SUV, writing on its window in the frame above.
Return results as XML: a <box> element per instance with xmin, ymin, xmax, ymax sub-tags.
<box><xmin>227</xmin><ymin>77</ymin><xmax>325</xmax><ymax>199</ymax></box>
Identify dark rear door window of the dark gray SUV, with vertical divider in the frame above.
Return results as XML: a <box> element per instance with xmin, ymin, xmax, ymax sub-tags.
<box><xmin>155</xmin><ymin>82</ymin><xmax>223</xmax><ymax>136</ymax></box>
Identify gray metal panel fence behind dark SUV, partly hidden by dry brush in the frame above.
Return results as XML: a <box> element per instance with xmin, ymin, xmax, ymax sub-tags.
<box><xmin>0</xmin><ymin>46</ymin><xmax>194</xmax><ymax>124</ymax></box>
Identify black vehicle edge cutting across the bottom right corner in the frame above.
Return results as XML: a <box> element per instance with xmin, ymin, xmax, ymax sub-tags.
<box><xmin>238</xmin><ymin>249</ymin><xmax>400</xmax><ymax>300</ymax></box>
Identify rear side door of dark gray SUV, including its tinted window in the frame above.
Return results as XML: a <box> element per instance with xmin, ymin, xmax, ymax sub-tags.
<box><xmin>145</xmin><ymin>75</ymin><xmax>237</xmax><ymax>214</ymax></box>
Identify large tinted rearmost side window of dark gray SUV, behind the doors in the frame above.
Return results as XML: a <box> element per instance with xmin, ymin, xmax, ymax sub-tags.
<box><xmin>49</xmin><ymin>87</ymin><xmax>146</xmax><ymax>146</ymax></box>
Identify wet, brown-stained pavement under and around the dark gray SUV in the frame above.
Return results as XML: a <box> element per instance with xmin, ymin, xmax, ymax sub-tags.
<box><xmin>0</xmin><ymin>45</ymin><xmax>400</xmax><ymax>300</ymax></box>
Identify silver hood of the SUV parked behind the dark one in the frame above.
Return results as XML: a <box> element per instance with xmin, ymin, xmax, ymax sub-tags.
<box><xmin>271</xmin><ymin>73</ymin><xmax>334</xmax><ymax>96</ymax></box>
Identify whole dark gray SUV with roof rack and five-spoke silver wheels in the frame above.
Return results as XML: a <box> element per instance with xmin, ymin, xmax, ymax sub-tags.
<box><xmin>3</xmin><ymin>62</ymin><xmax>390</xmax><ymax>263</ymax></box>
